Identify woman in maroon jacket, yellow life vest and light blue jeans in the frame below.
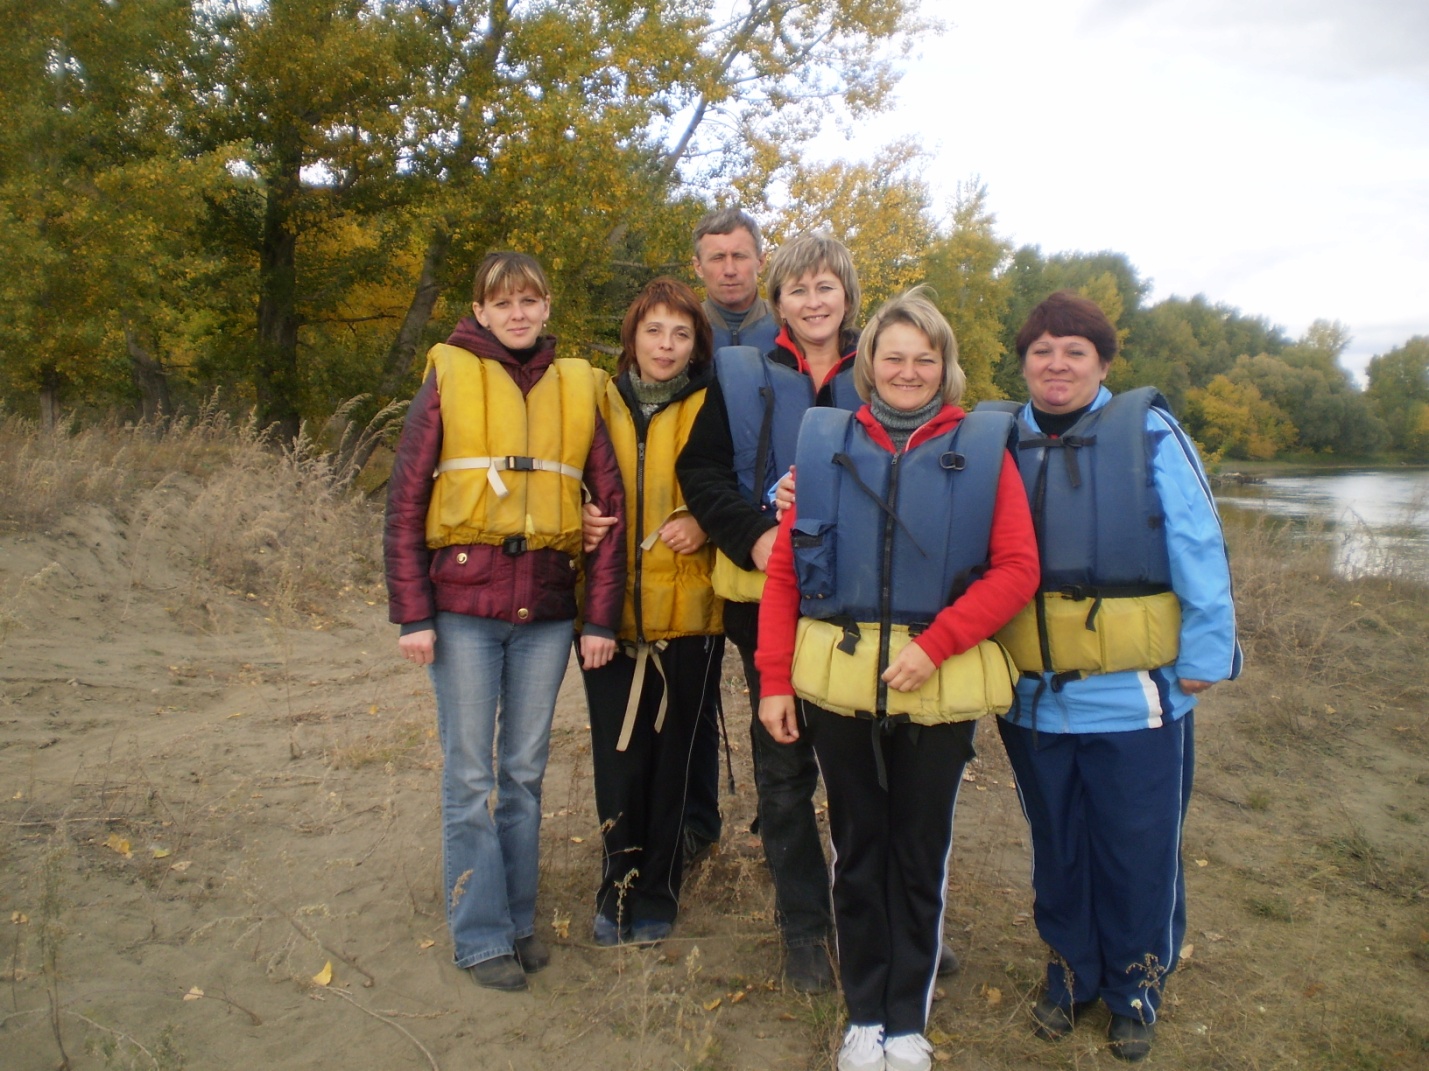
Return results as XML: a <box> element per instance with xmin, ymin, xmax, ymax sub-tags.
<box><xmin>384</xmin><ymin>253</ymin><xmax>624</xmax><ymax>989</ymax></box>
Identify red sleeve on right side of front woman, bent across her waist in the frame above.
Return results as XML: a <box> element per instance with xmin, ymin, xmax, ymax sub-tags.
<box><xmin>913</xmin><ymin>455</ymin><xmax>1042</xmax><ymax>665</ymax></box>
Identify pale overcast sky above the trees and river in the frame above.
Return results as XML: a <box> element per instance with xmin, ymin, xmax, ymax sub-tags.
<box><xmin>819</xmin><ymin>0</ymin><xmax>1429</xmax><ymax>383</ymax></box>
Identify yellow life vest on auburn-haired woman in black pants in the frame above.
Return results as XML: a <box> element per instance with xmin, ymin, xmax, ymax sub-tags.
<box><xmin>600</xmin><ymin>379</ymin><xmax>722</xmax><ymax>643</ymax></box>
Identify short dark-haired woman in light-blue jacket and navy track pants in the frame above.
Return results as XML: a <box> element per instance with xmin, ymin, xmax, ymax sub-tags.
<box><xmin>999</xmin><ymin>290</ymin><xmax>1240</xmax><ymax>1061</ymax></box>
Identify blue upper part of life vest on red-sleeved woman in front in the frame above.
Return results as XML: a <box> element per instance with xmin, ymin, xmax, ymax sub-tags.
<box><xmin>792</xmin><ymin>409</ymin><xmax>1013</xmax><ymax>635</ymax></box>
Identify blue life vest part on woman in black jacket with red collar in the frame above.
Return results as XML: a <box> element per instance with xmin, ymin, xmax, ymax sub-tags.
<box><xmin>715</xmin><ymin>346</ymin><xmax>863</xmax><ymax>508</ymax></box>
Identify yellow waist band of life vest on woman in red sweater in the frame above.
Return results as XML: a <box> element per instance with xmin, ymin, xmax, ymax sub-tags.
<box><xmin>790</xmin><ymin>618</ymin><xmax>1015</xmax><ymax>725</ymax></box>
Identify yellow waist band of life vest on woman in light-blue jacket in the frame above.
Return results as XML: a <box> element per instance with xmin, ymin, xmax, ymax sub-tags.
<box><xmin>997</xmin><ymin>592</ymin><xmax>1180</xmax><ymax>673</ymax></box>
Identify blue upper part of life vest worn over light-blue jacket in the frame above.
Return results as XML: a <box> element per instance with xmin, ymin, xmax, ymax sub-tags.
<box><xmin>983</xmin><ymin>388</ymin><xmax>1170</xmax><ymax>598</ymax></box>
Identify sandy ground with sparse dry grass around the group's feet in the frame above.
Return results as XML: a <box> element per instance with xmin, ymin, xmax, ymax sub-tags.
<box><xmin>0</xmin><ymin>416</ymin><xmax>1429</xmax><ymax>1071</ymax></box>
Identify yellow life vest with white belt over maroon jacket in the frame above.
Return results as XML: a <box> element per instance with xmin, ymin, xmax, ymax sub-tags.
<box><xmin>427</xmin><ymin>345</ymin><xmax>597</xmax><ymax>556</ymax></box>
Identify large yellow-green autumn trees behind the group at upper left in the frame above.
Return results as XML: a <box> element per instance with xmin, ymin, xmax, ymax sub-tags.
<box><xmin>0</xmin><ymin>0</ymin><xmax>923</xmax><ymax>432</ymax></box>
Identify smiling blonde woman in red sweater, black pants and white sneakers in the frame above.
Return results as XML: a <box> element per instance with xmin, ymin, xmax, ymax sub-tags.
<box><xmin>756</xmin><ymin>290</ymin><xmax>1037</xmax><ymax>1071</ymax></box>
